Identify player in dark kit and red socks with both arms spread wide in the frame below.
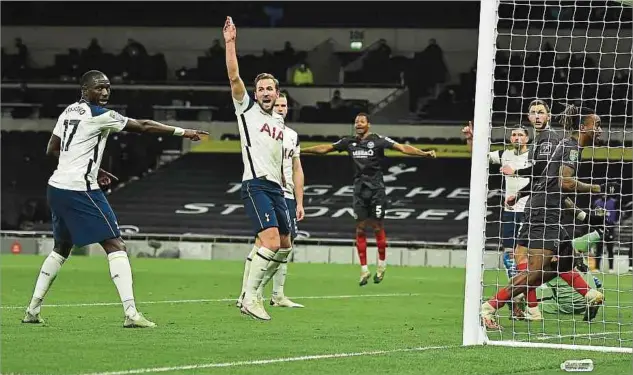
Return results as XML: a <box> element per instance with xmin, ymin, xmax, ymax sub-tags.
<box><xmin>302</xmin><ymin>113</ymin><xmax>435</xmax><ymax>286</ymax></box>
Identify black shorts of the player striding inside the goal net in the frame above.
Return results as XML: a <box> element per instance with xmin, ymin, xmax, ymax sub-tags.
<box><xmin>517</xmin><ymin>208</ymin><xmax>571</xmax><ymax>253</ymax></box>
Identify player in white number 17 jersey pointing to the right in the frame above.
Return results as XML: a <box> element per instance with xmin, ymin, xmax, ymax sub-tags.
<box><xmin>22</xmin><ymin>70</ymin><xmax>208</xmax><ymax>328</ymax></box>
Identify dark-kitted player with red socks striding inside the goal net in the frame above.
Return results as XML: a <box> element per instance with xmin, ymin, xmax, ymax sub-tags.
<box><xmin>481</xmin><ymin>106</ymin><xmax>620</xmax><ymax>329</ymax></box>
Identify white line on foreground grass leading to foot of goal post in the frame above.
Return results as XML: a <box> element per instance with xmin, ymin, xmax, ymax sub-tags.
<box><xmin>81</xmin><ymin>346</ymin><xmax>457</xmax><ymax>375</ymax></box>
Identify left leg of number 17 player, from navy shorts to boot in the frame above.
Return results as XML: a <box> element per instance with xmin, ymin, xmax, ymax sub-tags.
<box><xmin>22</xmin><ymin>186</ymin><xmax>73</xmax><ymax>323</ymax></box>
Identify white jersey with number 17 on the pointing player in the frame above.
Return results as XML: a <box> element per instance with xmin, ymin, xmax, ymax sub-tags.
<box><xmin>48</xmin><ymin>100</ymin><xmax>128</xmax><ymax>191</ymax></box>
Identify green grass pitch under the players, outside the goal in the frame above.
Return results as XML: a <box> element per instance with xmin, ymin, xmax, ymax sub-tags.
<box><xmin>0</xmin><ymin>255</ymin><xmax>633</xmax><ymax>375</ymax></box>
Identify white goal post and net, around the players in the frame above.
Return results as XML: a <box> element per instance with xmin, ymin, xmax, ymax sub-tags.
<box><xmin>463</xmin><ymin>0</ymin><xmax>633</xmax><ymax>352</ymax></box>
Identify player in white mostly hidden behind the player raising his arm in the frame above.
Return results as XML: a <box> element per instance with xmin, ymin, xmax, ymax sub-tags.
<box><xmin>237</xmin><ymin>93</ymin><xmax>305</xmax><ymax>308</ymax></box>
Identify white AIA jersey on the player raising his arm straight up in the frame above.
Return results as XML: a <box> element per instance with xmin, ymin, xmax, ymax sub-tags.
<box><xmin>233</xmin><ymin>94</ymin><xmax>285</xmax><ymax>187</ymax></box>
